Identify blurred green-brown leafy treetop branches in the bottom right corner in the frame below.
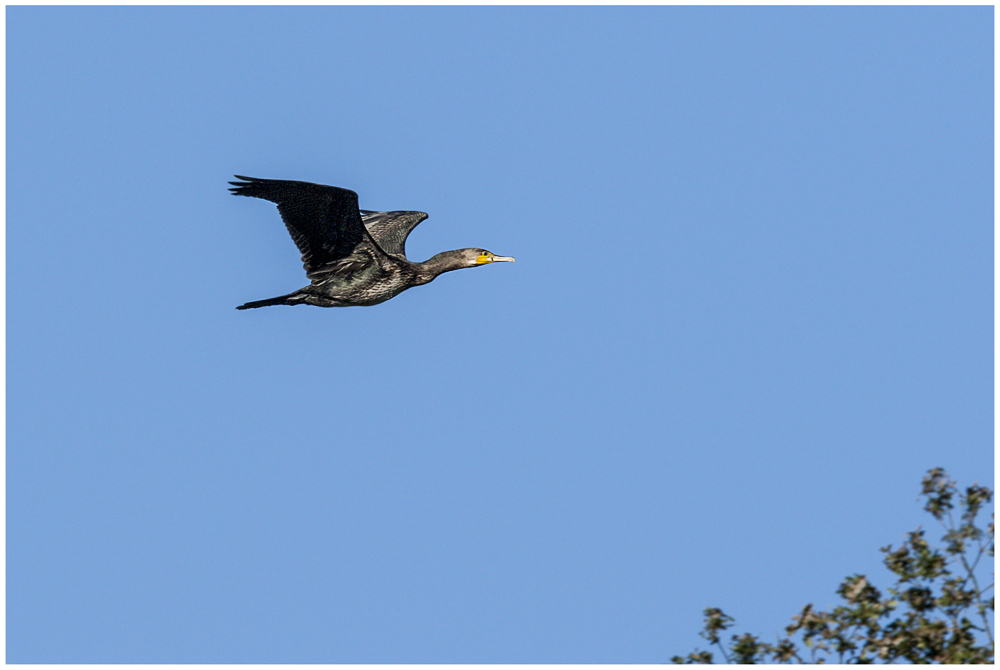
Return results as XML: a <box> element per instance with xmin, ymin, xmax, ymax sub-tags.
<box><xmin>671</xmin><ymin>468</ymin><xmax>994</xmax><ymax>663</ymax></box>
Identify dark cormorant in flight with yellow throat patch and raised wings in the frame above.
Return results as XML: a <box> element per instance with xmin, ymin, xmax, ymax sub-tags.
<box><xmin>229</xmin><ymin>175</ymin><xmax>514</xmax><ymax>309</ymax></box>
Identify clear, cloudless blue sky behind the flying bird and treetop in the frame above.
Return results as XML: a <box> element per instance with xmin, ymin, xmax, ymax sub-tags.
<box><xmin>7</xmin><ymin>7</ymin><xmax>993</xmax><ymax>663</ymax></box>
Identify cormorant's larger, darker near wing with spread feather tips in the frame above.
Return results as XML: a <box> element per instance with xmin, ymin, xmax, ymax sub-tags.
<box><xmin>229</xmin><ymin>175</ymin><xmax>376</xmax><ymax>274</ymax></box>
